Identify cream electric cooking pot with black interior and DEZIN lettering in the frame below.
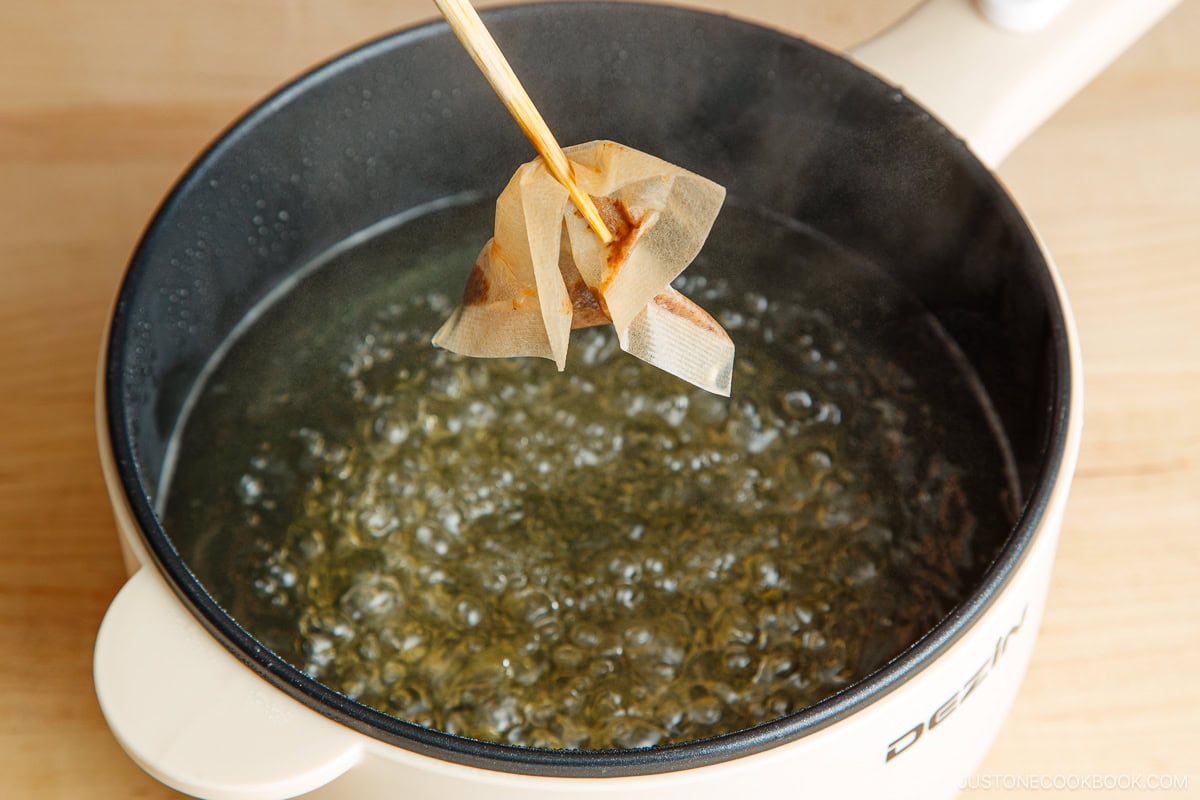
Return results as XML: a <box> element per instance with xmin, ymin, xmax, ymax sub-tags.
<box><xmin>95</xmin><ymin>0</ymin><xmax>1171</xmax><ymax>799</ymax></box>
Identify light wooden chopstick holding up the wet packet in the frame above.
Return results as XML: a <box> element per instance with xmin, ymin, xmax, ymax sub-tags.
<box><xmin>433</xmin><ymin>0</ymin><xmax>613</xmax><ymax>245</ymax></box>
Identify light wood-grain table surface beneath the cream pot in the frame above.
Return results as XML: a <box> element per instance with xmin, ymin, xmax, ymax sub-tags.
<box><xmin>0</xmin><ymin>0</ymin><xmax>1200</xmax><ymax>799</ymax></box>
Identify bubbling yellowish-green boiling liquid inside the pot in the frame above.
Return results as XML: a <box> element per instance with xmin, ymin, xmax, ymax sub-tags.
<box><xmin>164</xmin><ymin>205</ymin><xmax>1015</xmax><ymax>748</ymax></box>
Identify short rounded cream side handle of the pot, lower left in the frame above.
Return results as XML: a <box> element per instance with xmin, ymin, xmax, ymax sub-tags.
<box><xmin>94</xmin><ymin>567</ymin><xmax>361</xmax><ymax>800</ymax></box>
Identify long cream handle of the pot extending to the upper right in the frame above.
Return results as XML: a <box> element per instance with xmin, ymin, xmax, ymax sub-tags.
<box><xmin>851</xmin><ymin>0</ymin><xmax>1178</xmax><ymax>167</ymax></box>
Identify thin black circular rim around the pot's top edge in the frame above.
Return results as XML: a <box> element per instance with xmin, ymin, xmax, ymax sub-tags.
<box><xmin>105</xmin><ymin>0</ymin><xmax>1081</xmax><ymax>777</ymax></box>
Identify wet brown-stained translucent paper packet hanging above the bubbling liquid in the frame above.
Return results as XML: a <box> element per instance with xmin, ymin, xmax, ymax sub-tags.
<box><xmin>433</xmin><ymin>142</ymin><xmax>733</xmax><ymax>396</ymax></box>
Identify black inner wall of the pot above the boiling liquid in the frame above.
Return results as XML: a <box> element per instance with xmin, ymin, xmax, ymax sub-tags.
<box><xmin>107</xmin><ymin>4</ymin><xmax>1068</xmax><ymax>775</ymax></box>
